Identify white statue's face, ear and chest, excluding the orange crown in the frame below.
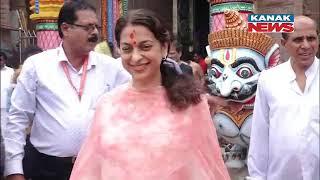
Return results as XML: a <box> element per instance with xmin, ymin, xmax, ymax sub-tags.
<box><xmin>206</xmin><ymin>44</ymin><xmax>279</xmax><ymax>147</ymax></box>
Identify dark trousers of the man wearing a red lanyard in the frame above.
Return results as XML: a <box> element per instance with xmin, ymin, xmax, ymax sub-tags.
<box><xmin>23</xmin><ymin>138</ymin><xmax>73</xmax><ymax>180</ymax></box>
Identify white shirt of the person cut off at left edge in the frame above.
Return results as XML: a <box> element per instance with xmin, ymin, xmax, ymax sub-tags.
<box><xmin>1</xmin><ymin>66</ymin><xmax>14</xmax><ymax>109</ymax></box>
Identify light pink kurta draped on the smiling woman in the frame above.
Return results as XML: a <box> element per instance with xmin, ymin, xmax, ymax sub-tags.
<box><xmin>71</xmin><ymin>85</ymin><xmax>230</xmax><ymax>180</ymax></box>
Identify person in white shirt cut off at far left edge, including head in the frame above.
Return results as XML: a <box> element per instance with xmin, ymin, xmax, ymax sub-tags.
<box><xmin>0</xmin><ymin>52</ymin><xmax>14</xmax><ymax>135</ymax></box>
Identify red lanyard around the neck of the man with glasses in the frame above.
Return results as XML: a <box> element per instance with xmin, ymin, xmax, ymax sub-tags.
<box><xmin>61</xmin><ymin>57</ymin><xmax>88</xmax><ymax>100</ymax></box>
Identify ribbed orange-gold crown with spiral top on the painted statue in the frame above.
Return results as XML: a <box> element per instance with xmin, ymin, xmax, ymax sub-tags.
<box><xmin>208</xmin><ymin>11</ymin><xmax>274</xmax><ymax>55</ymax></box>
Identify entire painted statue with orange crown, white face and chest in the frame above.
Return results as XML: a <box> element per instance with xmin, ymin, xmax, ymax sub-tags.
<box><xmin>206</xmin><ymin>11</ymin><xmax>280</xmax><ymax>150</ymax></box>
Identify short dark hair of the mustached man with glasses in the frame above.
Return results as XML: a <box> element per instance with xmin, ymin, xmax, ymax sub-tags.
<box><xmin>58</xmin><ymin>0</ymin><xmax>96</xmax><ymax>38</ymax></box>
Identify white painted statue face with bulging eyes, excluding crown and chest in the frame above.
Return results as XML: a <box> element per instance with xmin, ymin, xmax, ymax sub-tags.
<box><xmin>206</xmin><ymin>44</ymin><xmax>279</xmax><ymax>103</ymax></box>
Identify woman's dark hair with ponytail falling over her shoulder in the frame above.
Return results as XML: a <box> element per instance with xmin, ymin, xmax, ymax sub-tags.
<box><xmin>115</xmin><ymin>9</ymin><xmax>203</xmax><ymax>110</ymax></box>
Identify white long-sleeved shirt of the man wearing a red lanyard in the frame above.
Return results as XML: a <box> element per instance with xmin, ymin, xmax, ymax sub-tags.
<box><xmin>4</xmin><ymin>46</ymin><xmax>130</xmax><ymax>175</ymax></box>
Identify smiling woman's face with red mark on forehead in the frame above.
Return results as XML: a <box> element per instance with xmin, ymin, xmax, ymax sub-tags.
<box><xmin>120</xmin><ymin>24</ymin><xmax>167</xmax><ymax>82</ymax></box>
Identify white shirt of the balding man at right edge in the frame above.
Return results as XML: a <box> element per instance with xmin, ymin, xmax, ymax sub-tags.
<box><xmin>248</xmin><ymin>57</ymin><xmax>319</xmax><ymax>180</ymax></box>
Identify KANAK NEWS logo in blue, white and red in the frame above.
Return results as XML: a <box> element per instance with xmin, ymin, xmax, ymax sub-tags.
<box><xmin>248</xmin><ymin>14</ymin><xmax>294</xmax><ymax>33</ymax></box>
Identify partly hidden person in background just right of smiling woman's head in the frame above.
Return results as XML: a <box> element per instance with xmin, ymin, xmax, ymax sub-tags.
<box><xmin>168</xmin><ymin>36</ymin><xmax>193</xmax><ymax>76</ymax></box>
